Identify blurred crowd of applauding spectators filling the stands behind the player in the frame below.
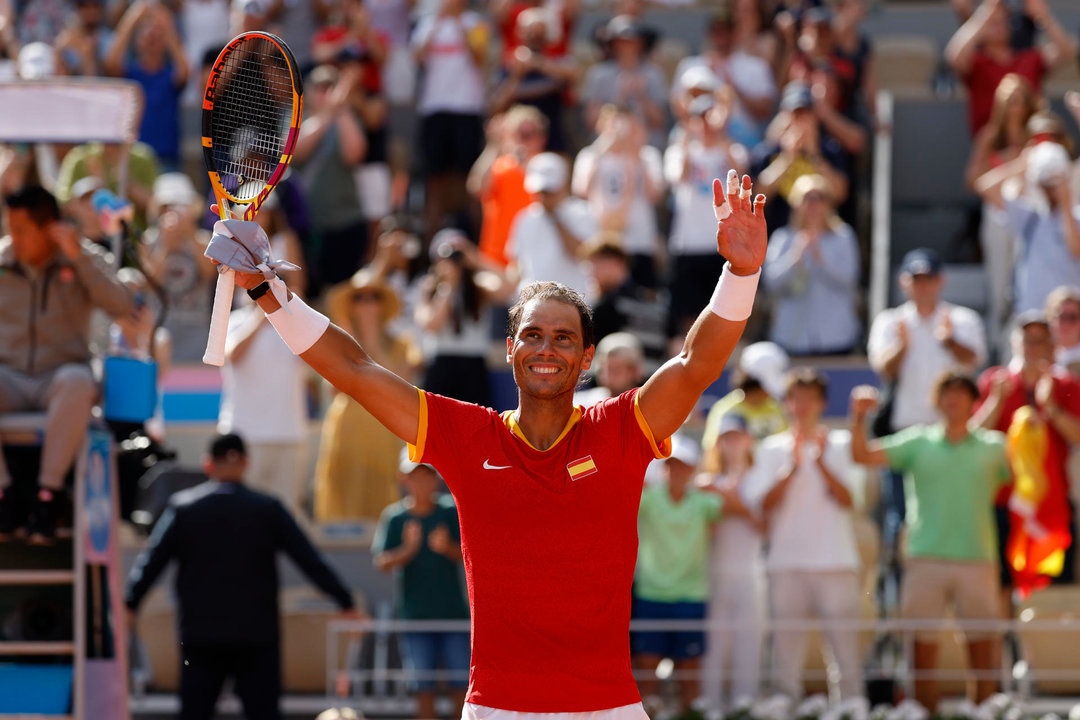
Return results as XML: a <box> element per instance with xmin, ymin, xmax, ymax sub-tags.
<box><xmin>0</xmin><ymin>0</ymin><xmax>1080</xmax><ymax>709</ymax></box>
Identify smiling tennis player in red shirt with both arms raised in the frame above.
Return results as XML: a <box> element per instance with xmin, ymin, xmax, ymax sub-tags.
<box><xmin>212</xmin><ymin>171</ymin><xmax>767</xmax><ymax>720</ymax></box>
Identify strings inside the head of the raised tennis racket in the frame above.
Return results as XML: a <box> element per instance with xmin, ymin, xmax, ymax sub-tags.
<box><xmin>211</xmin><ymin>38</ymin><xmax>294</xmax><ymax>201</ymax></box>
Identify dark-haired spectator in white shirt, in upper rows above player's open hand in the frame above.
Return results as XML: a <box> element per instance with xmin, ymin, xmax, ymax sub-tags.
<box><xmin>672</xmin><ymin>10</ymin><xmax>777</xmax><ymax>148</ymax></box>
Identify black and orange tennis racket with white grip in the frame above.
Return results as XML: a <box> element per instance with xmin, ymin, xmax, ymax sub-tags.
<box><xmin>202</xmin><ymin>32</ymin><xmax>303</xmax><ymax>366</ymax></box>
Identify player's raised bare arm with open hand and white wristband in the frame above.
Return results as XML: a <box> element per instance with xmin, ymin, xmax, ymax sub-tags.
<box><xmin>637</xmin><ymin>171</ymin><xmax>768</xmax><ymax>439</ymax></box>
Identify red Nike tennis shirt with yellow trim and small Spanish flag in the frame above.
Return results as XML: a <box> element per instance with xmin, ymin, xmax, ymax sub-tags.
<box><xmin>409</xmin><ymin>390</ymin><xmax>671</xmax><ymax>712</ymax></box>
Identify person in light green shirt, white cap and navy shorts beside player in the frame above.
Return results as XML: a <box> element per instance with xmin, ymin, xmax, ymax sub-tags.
<box><xmin>633</xmin><ymin>435</ymin><xmax>724</xmax><ymax>717</ymax></box>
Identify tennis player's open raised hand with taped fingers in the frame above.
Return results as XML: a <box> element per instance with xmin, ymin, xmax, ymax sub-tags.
<box><xmin>713</xmin><ymin>169</ymin><xmax>769</xmax><ymax>275</ymax></box>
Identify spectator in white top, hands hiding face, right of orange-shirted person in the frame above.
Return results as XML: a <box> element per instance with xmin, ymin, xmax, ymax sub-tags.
<box><xmin>571</xmin><ymin>106</ymin><xmax>664</xmax><ymax>288</ymax></box>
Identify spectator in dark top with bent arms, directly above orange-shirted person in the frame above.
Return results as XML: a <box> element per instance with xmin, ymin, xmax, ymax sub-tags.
<box><xmin>491</xmin><ymin>8</ymin><xmax>578</xmax><ymax>152</ymax></box>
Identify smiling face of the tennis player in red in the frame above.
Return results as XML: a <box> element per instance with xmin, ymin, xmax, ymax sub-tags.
<box><xmin>507</xmin><ymin>298</ymin><xmax>595</xmax><ymax>399</ymax></box>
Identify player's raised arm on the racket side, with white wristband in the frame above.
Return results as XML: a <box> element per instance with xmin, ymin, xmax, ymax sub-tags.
<box><xmin>235</xmin><ymin>272</ymin><xmax>420</xmax><ymax>444</ymax></box>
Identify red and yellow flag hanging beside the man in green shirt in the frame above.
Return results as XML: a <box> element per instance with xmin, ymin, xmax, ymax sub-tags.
<box><xmin>1005</xmin><ymin>405</ymin><xmax>1072</xmax><ymax>598</ymax></box>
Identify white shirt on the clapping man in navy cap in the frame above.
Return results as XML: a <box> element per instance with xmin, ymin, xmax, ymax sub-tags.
<box><xmin>866</xmin><ymin>301</ymin><xmax>986</xmax><ymax>430</ymax></box>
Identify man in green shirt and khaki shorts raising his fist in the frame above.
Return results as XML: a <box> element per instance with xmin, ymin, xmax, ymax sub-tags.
<box><xmin>851</xmin><ymin>371</ymin><xmax>1010</xmax><ymax>712</ymax></box>
